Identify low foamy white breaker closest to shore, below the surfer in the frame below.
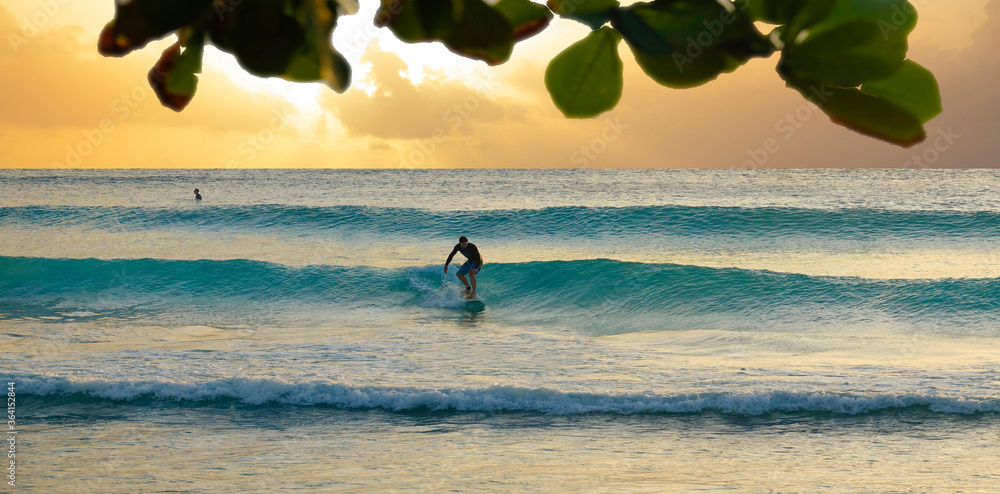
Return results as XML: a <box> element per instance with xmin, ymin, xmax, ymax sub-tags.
<box><xmin>18</xmin><ymin>376</ymin><xmax>1000</xmax><ymax>415</ymax></box>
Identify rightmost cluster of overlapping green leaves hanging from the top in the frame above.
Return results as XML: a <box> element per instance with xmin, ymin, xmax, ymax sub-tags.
<box><xmin>778</xmin><ymin>0</ymin><xmax>928</xmax><ymax>147</ymax></box>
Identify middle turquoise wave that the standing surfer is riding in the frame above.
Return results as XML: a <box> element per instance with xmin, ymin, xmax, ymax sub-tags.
<box><xmin>0</xmin><ymin>257</ymin><xmax>1000</xmax><ymax>332</ymax></box>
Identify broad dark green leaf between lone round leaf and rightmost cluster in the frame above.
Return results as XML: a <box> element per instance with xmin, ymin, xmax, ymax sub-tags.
<box><xmin>612</xmin><ymin>0</ymin><xmax>774</xmax><ymax>88</ymax></box>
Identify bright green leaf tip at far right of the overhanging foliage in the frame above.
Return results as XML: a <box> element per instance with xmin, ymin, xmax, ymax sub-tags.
<box><xmin>861</xmin><ymin>60</ymin><xmax>943</xmax><ymax>123</ymax></box>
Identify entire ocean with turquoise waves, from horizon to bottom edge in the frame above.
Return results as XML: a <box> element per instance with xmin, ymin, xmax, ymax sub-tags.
<box><xmin>0</xmin><ymin>170</ymin><xmax>1000</xmax><ymax>493</ymax></box>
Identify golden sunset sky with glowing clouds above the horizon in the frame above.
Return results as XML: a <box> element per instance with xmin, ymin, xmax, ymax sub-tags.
<box><xmin>0</xmin><ymin>0</ymin><xmax>1000</xmax><ymax>168</ymax></box>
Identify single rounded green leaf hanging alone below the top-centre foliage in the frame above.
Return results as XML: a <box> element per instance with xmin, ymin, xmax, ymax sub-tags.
<box><xmin>545</xmin><ymin>27</ymin><xmax>624</xmax><ymax>118</ymax></box>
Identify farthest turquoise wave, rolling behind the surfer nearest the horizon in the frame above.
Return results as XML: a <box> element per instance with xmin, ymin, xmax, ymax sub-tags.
<box><xmin>0</xmin><ymin>205</ymin><xmax>1000</xmax><ymax>240</ymax></box>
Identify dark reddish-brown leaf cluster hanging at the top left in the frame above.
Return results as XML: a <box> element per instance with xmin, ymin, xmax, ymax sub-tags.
<box><xmin>98</xmin><ymin>0</ymin><xmax>357</xmax><ymax>111</ymax></box>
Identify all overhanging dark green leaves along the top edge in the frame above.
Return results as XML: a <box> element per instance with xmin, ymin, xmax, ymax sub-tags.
<box><xmin>99</xmin><ymin>0</ymin><xmax>941</xmax><ymax>146</ymax></box>
